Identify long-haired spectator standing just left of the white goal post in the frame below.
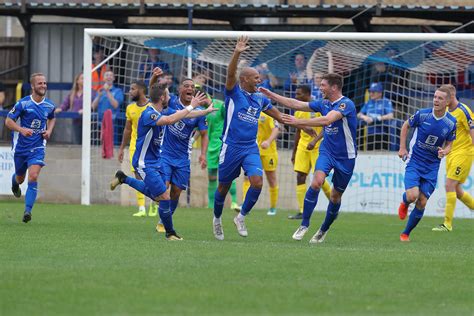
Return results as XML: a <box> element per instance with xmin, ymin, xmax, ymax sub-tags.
<box><xmin>55</xmin><ymin>72</ymin><xmax>97</xmax><ymax>144</ymax></box>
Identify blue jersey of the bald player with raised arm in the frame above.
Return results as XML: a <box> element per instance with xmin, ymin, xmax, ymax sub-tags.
<box><xmin>222</xmin><ymin>85</ymin><xmax>272</xmax><ymax>146</ymax></box>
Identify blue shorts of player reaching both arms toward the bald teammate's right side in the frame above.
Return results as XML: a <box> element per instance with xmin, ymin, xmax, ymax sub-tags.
<box><xmin>314</xmin><ymin>152</ymin><xmax>355</xmax><ymax>193</ymax></box>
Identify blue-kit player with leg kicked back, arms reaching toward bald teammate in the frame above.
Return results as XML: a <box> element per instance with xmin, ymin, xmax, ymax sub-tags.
<box><xmin>110</xmin><ymin>78</ymin><xmax>213</xmax><ymax>240</ymax></box>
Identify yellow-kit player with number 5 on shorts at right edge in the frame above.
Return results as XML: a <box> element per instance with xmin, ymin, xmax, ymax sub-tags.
<box><xmin>433</xmin><ymin>84</ymin><xmax>474</xmax><ymax>232</ymax></box>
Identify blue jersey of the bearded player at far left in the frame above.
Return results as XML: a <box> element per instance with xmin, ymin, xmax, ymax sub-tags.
<box><xmin>8</xmin><ymin>95</ymin><xmax>55</xmax><ymax>152</ymax></box>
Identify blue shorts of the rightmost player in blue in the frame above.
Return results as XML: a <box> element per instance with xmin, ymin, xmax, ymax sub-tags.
<box><xmin>405</xmin><ymin>160</ymin><xmax>439</xmax><ymax>199</ymax></box>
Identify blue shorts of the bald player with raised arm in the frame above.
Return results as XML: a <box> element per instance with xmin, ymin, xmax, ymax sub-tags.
<box><xmin>218</xmin><ymin>143</ymin><xmax>263</xmax><ymax>183</ymax></box>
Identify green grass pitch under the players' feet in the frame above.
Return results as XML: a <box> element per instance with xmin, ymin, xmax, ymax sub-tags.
<box><xmin>0</xmin><ymin>202</ymin><xmax>474</xmax><ymax>315</ymax></box>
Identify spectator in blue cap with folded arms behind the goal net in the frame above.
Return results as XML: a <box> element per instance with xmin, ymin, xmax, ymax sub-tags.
<box><xmin>357</xmin><ymin>82</ymin><xmax>393</xmax><ymax>150</ymax></box>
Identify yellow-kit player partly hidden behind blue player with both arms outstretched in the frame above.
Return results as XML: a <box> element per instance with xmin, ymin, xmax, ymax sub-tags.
<box><xmin>288</xmin><ymin>85</ymin><xmax>331</xmax><ymax>219</ymax></box>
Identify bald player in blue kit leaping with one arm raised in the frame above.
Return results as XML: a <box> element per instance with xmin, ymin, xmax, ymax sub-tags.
<box><xmin>213</xmin><ymin>36</ymin><xmax>281</xmax><ymax>240</ymax></box>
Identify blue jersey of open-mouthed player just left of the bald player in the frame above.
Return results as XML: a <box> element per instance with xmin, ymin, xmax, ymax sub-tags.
<box><xmin>161</xmin><ymin>98</ymin><xmax>207</xmax><ymax>160</ymax></box>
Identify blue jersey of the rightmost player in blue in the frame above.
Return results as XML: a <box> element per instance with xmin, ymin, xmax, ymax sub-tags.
<box><xmin>408</xmin><ymin>108</ymin><xmax>456</xmax><ymax>166</ymax></box>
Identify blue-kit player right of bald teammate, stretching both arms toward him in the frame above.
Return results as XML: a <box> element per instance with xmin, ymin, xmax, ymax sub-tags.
<box><xmin>260</xmin><ymin>74</ymin><xmax>357</xmax><ymax>243</ymax></box>
